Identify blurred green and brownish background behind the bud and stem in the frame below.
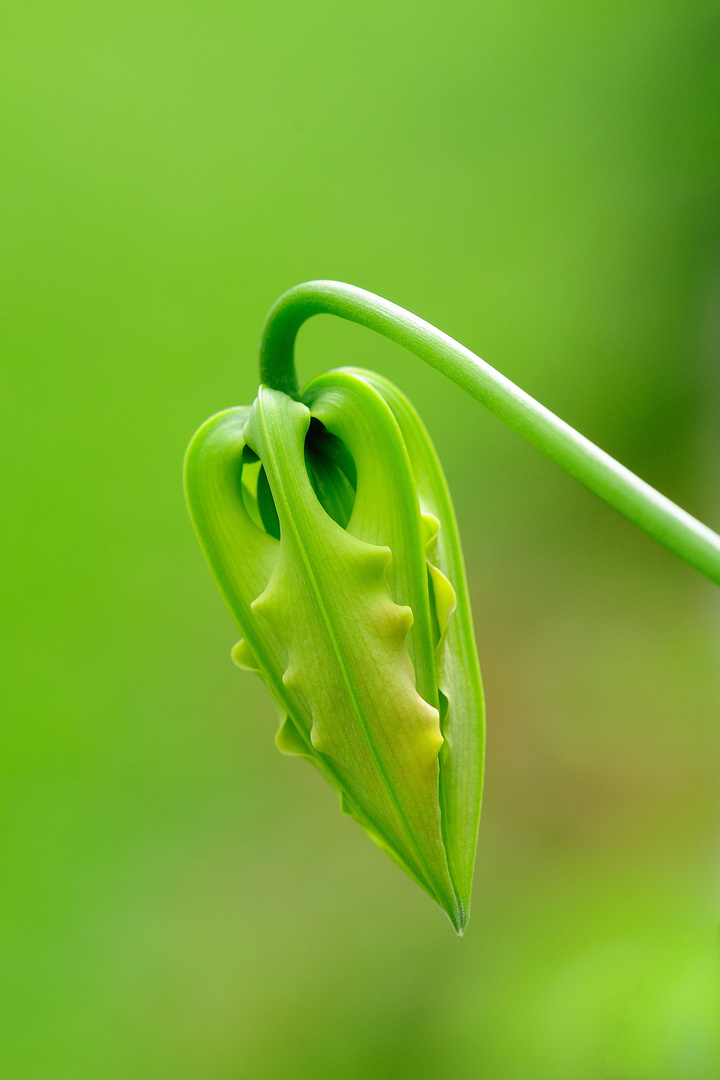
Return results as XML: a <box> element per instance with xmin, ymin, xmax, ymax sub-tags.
<box><xmin>0</xmin><ymin>0</ymin><xmax>720</xmax><ymax>1080</ymax></box>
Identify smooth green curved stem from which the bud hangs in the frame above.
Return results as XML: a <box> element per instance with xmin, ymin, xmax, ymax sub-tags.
<box><xmin>260</xmin><ymin>281</ymin><xmax>720</xmax><ymax>584</ymax></box>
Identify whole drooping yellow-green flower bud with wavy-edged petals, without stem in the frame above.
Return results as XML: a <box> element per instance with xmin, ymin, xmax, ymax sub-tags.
<box><xmin>186</xmin><ymin>368</ymin><xmax>484</xmax><ymax>933</ymax></box>
